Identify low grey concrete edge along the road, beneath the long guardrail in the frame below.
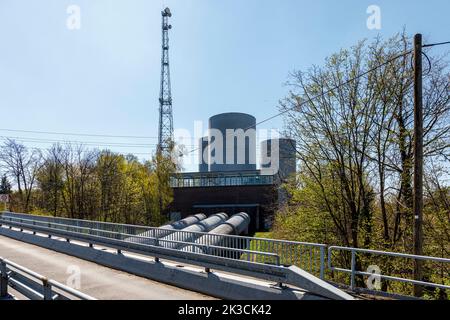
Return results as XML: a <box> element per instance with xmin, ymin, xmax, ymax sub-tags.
<box><xmin>0</xmin><ymin>228</ymin><xmax>326</xmax><ymax>300</ymax></box>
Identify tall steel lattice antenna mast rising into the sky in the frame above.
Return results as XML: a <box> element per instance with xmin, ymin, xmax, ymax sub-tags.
<box><xmin>158</xmin><ymin>8</ymin><xmax>173</xmax><ymax>157</ymax></box>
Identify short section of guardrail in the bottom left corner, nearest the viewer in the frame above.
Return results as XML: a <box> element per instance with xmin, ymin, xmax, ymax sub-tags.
<box><xmin>0</xmin><ymin>257</ymin><xmax>96</xmax><ymax>300</ymax></box>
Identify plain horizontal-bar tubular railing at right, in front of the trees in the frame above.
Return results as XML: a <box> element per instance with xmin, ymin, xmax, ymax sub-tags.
<box><xmin>328</xmin><ymin>246</ymin><xmax>450</xmax><ymax>296</ymax></box>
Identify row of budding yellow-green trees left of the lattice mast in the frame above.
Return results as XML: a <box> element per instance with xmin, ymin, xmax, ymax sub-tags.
<box><xmin>0</xmin><ymin>139</ymin><xmax>176</xmax><ymax>226</ymax></box>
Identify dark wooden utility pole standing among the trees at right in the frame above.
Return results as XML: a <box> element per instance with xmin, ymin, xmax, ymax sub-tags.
<box><xmin>413</xmin><ymin>33</ymin><xmax>423</xmax><ymax>297</ymax></box>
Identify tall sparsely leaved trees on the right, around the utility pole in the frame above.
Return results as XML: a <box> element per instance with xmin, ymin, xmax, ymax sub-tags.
<box><xmin>273</xmin><ymin>33</ymin><xmax>450</xmax><ymax>298</ymax></box>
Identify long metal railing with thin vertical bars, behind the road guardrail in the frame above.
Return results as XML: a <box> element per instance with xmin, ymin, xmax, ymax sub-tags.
<box><xmin>0</xmin><ymin>212</ymin><xmax>326</xmax><ymax>279</ymax></box>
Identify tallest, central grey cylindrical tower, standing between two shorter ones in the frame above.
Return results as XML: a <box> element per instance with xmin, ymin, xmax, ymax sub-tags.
<box><xmin>209</xmin><ymin>112</ymin><xmax>256</xmax><ymax>172</ymax></box>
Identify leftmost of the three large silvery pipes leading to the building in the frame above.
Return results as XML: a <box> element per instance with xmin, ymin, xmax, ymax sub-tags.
<box><xmin>125</xmin><ymin>213</ymin><xmax>206</xmax><ymax>244</ymax></box>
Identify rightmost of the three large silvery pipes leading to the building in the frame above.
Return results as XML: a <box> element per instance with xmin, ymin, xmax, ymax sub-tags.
<box><xmin>183</xmin><ymin>212</ymin><xmax>250</xmax><ymax>253</ymax></box>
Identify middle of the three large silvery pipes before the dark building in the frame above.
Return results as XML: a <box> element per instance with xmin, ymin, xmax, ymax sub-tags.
<box><xmin>159</xmin><ymin>212</ymin><xmax>228</xmax><ymax>249</ymax></box>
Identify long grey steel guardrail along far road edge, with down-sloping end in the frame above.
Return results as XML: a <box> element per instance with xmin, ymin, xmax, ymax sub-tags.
<box><xmin>0</xmin><ymin>217</ymin><xmax>353</xmax><ymax>300</ymax></box>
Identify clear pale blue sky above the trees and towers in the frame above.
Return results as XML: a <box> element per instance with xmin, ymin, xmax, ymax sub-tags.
<box><xmin>0</xmin><ymin>0</ymin><xmax>450</xmax><ymax>169</ymax></box>
